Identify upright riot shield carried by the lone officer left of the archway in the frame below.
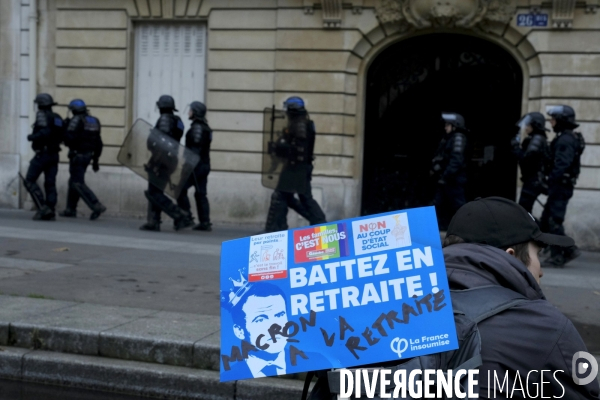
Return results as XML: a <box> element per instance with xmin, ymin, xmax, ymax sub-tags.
<box><xmin>262</xmin><ymin>106</ymin><xmax>288</xmax><ymax>189</ymax></box>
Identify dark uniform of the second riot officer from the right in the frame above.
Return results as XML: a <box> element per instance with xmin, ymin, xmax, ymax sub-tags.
<box><xmin>512</xmin><ymin>130</ymin><xmax>549</xmax><ymax>213</ymax></box>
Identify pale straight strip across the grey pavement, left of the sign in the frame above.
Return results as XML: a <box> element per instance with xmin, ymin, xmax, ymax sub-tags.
<box><xmin>0</xmin><ymin>227</ymin><xmax>221</xmax><ymax>256</ymax></box>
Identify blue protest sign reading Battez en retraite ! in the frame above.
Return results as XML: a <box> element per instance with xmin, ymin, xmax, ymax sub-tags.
<box><xmin>221</xmin><ymin>207</ymin><xmax>458</xmax><ymax>381</ymax></box>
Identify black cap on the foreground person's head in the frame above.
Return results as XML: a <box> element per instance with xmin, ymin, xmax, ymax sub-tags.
<box><xmin>446</xmin><ymin>197</ymin><xmax>575</xmax><ymax>248</ymax></box>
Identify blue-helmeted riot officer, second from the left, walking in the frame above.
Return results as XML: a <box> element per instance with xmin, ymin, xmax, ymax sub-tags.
<box><xmin>60</xmin><ymin>99</ymin><xmax>106</xmax><ymax>221</ymax></box>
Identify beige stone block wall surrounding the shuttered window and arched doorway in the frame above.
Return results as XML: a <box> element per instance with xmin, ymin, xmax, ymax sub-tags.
<box><xmin>3</xmin><ymin>0</ymin><xmax>600</xmax><ymax>248</ymax></box>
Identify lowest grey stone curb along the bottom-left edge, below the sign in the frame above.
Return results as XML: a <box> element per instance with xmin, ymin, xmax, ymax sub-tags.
<box><xmin>0</xmin><ymin>347</ymin><xmax>303</xmax><ymax>400</ymax></box>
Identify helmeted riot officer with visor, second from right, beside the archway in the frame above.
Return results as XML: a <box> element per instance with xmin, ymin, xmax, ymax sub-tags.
<box><xmin>511</xmin><ymin>112</ymin><xmax>549</xmax><ymax>213</ymax></box>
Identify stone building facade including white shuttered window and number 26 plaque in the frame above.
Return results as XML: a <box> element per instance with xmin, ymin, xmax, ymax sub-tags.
<box><xmin>0</xmin><ymin>0</ymin><xmax>600</xmax><ymax>248</ymax></box>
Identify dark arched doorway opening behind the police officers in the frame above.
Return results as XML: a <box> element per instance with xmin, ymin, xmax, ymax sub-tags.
<box><xmin>361</xmin><ymin>33</ymin><xmax>523</xmax><ymax>215</ymax></box>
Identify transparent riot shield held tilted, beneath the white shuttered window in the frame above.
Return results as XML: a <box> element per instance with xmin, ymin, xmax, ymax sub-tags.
<box><xmin>117</xmin><ymin>119</ymin><xmax>200</xmax><ymax>199</ymax></box>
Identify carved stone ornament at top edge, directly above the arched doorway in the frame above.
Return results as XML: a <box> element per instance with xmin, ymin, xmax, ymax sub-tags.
<box><xmin>376</xmin><ymin>0</ymin><xmax>516</xmax><ymax>29</ymax></box>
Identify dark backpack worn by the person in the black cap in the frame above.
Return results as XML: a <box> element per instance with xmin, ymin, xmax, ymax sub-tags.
<box><xmin>302</xmin><ymin>285</ymin><xmax>527</xmax><ymax>400</ymax></box>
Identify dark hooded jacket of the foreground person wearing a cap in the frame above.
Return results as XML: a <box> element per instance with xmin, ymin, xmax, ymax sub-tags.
<box><xmin>444</xmin><ymin>243</ymin><xmax>600</xmax><ymax>399</ymax></box>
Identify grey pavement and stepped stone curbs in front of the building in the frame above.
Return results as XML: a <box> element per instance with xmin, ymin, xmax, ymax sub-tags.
<box><xmin>0</xmin><ymin>210</ymin><xmax>600</xmax><ymax>399</ymax></box>
